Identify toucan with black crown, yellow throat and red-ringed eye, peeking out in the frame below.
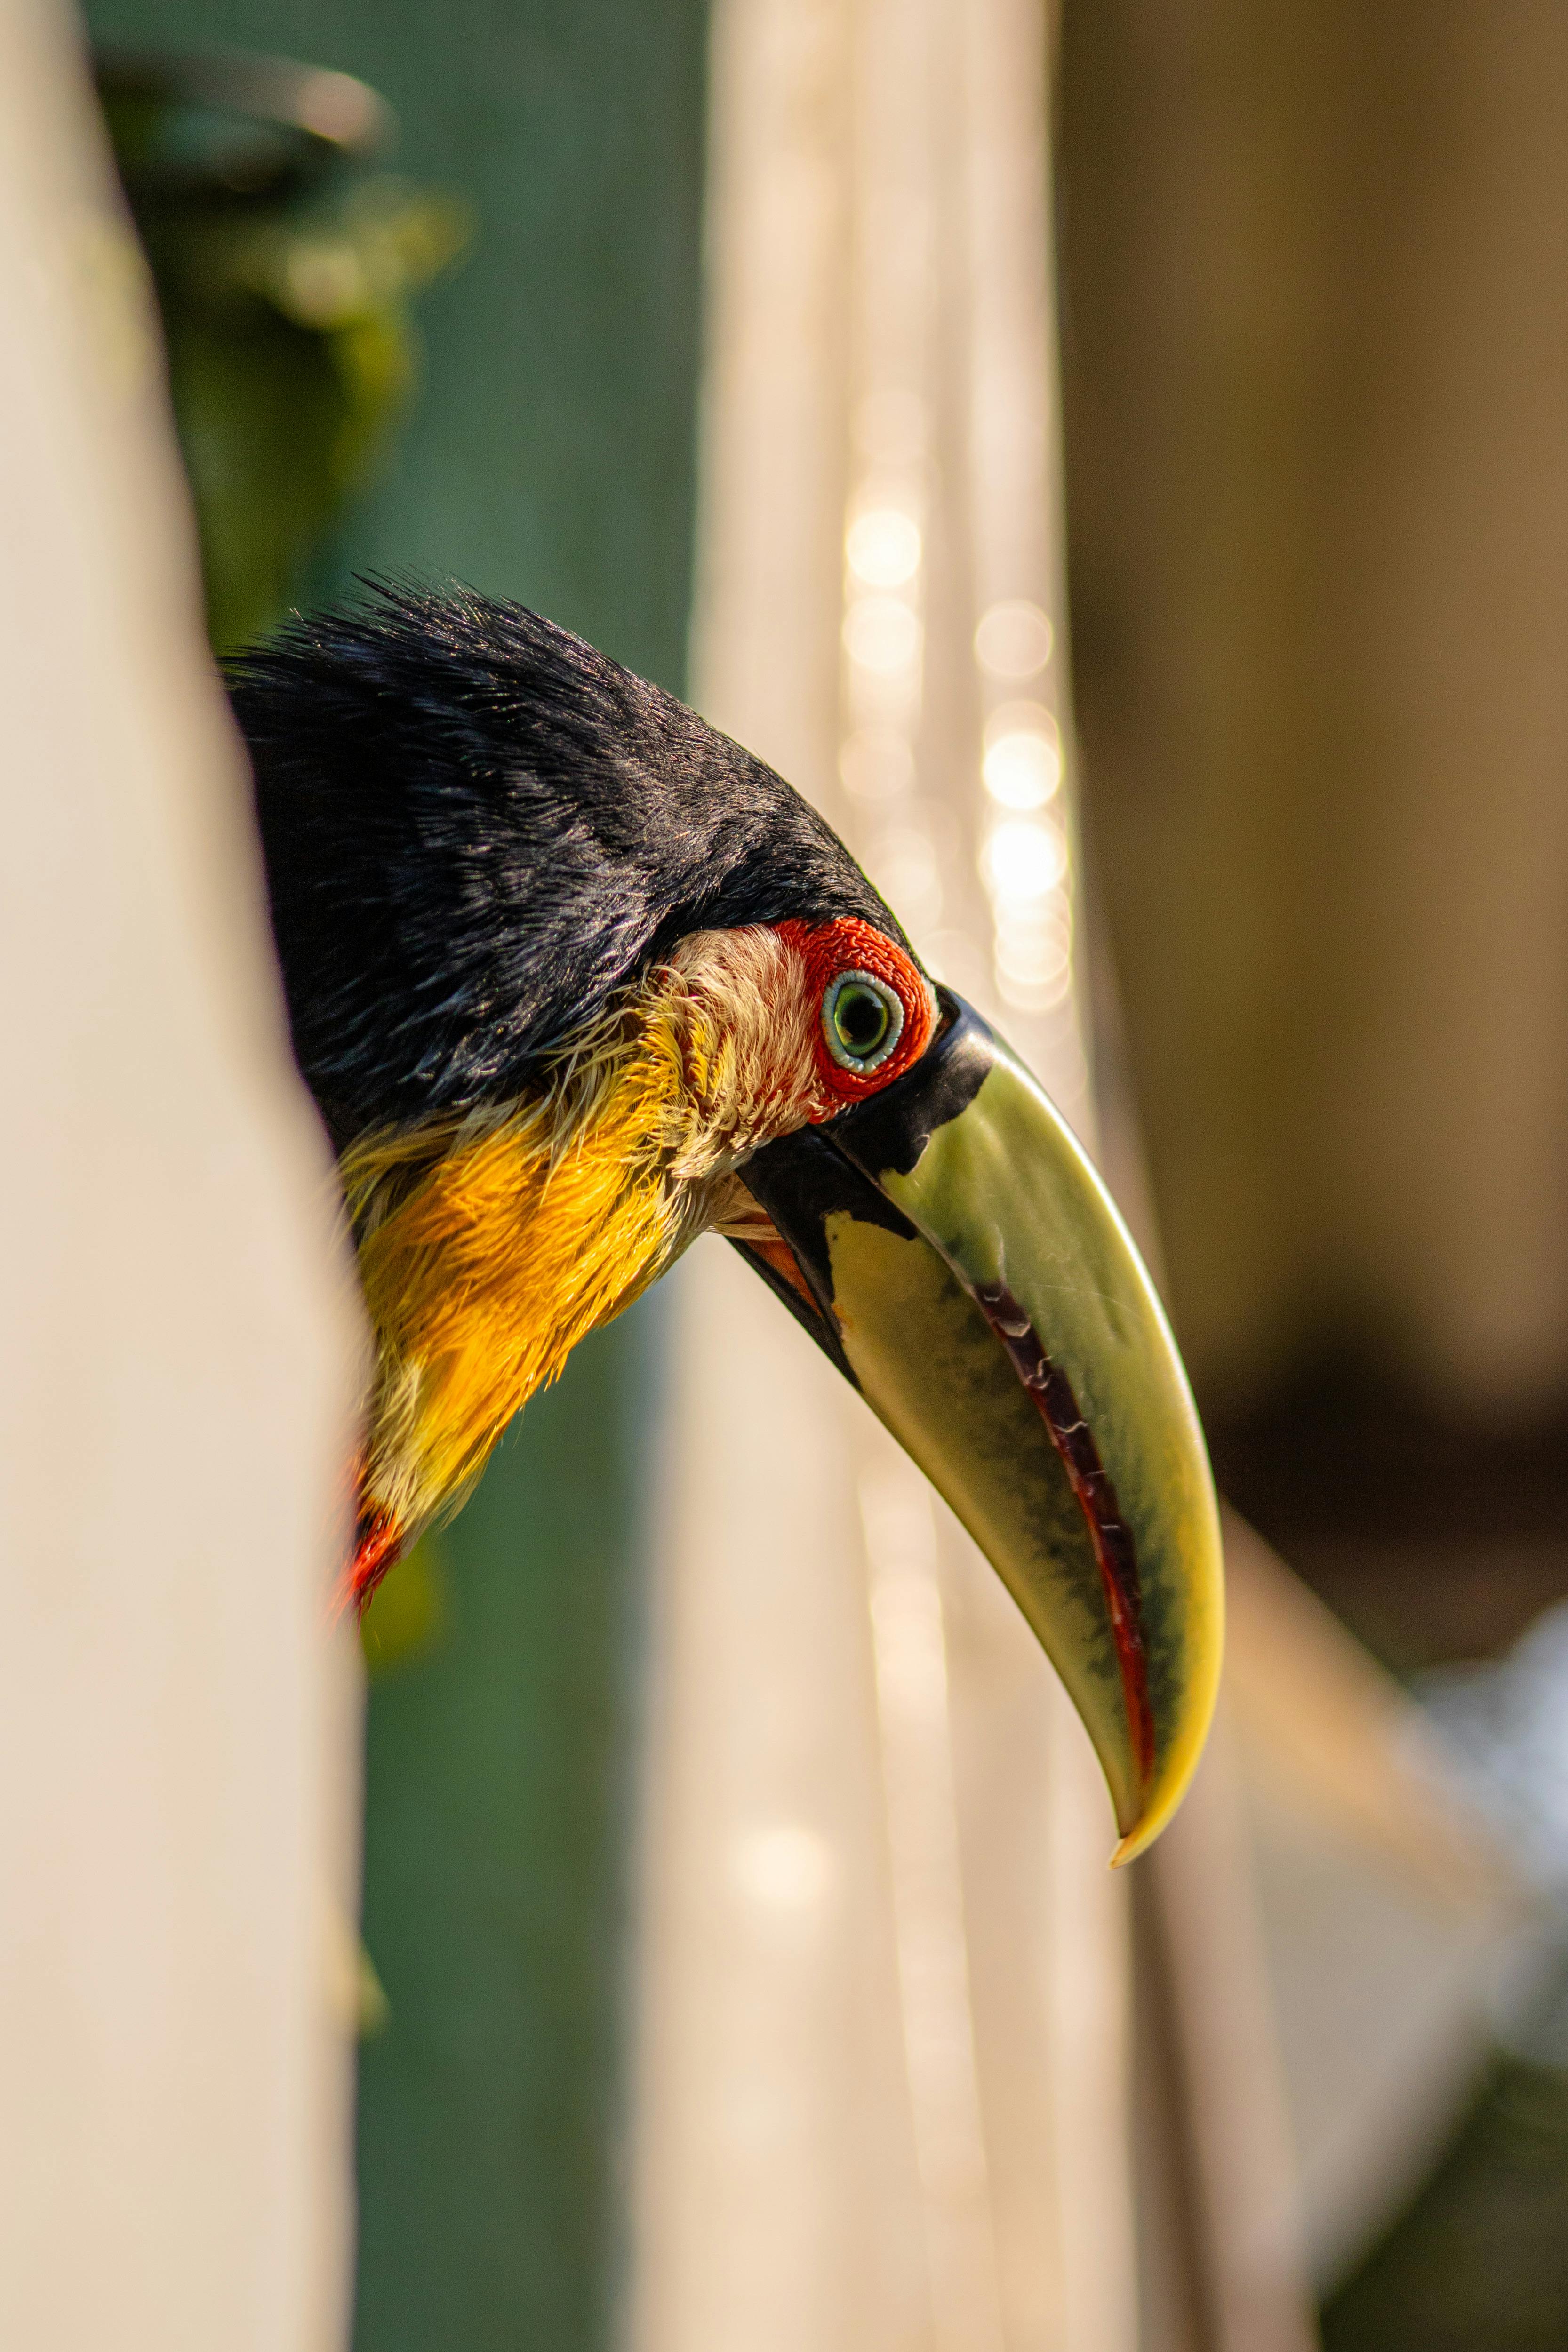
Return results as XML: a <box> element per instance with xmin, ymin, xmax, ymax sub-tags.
<box><xmin>228</xmin><ymin>581</ymin><xmax>1223</xmax><ymax>1860</ymax></box>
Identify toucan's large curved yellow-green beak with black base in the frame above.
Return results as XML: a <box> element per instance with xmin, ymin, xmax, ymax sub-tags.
<box><xmin>736</xmin><ymin>992</ymin><xmax>1225</xmax><ymax>1863</ymax></box>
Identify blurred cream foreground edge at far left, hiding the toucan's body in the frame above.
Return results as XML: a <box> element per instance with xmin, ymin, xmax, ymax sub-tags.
<box><xmin>0</xmin><ymin>0</ymin><xmax>357</xmax><ymax>2352</ymax></box>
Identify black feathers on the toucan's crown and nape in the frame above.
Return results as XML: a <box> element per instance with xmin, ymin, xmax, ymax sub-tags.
<box><xmin>231</xmin><ymin>584</ymin><xmax>903</xmax><ymax>1143</ymax></box>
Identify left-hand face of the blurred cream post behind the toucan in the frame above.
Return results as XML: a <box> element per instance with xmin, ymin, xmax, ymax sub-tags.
<box><xmin>628</xmin><ymin>0</ymin><xmax>928</xmax><ymax>2352</ymax></box>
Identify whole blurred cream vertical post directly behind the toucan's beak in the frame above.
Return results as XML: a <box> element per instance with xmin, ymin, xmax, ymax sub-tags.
<box><xmin>630</xmin><ymin>0</ymin><xmax>1136</xmax><ymax>2352</ymax></box>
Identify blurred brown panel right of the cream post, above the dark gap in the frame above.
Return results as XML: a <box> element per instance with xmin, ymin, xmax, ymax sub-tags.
<box><xmin>1060</xmin><ymin>0</ymin><xmax>1568</xmax><ymax>1407</ymax></box>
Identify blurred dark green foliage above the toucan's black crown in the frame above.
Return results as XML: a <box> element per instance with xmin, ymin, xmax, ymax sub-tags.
<box><xmin>99</xmin><ymin>56</ymin><xmax>472</xmax><ymax>651</ymax></box>
